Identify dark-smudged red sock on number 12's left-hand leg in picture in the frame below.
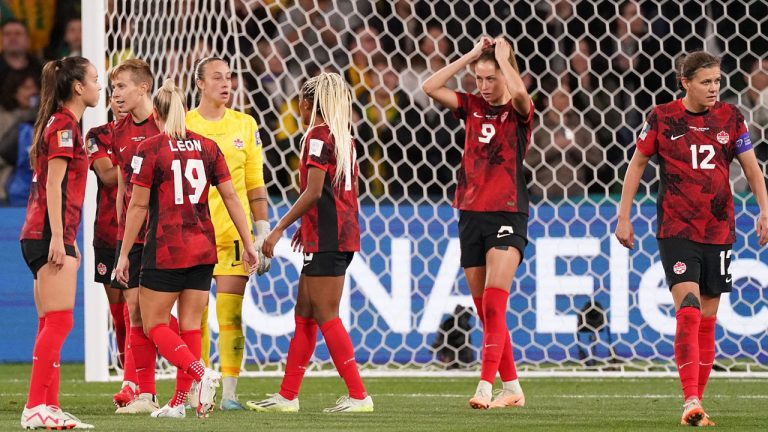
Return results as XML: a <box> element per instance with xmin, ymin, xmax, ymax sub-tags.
<box><xmin>675</xmin><ymin>307</ymin><xmax>701</xmax><ymax>400</ymax></box>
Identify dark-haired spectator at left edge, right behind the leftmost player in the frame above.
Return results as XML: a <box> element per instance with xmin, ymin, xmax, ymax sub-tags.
<box><xmin>0</xmin><ymin>71</ymin><xmax>40</xmax><ymax>202</ymax></box>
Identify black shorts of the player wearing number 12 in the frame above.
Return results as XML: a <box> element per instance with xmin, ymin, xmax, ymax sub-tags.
<box><xmin>658</xmin><ymin>238</ymin><xmax>733</xmax><ymax>297</ymax></box>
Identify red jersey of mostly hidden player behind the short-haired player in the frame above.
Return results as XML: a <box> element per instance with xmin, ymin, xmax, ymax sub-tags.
<box><xmin>85</xmin><ymin>122</ymin><xmax>117</xmax><ymax>249</ymax></box>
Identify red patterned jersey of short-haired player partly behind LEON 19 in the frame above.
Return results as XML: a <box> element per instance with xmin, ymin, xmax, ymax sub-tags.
<box><xmin>112</xmin><ymin>115</ymin><xmax>160</xmax><ymax>243</ymax></box>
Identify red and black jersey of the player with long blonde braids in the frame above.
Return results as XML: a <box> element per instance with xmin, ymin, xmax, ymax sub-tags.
<box><xmin>299</xmin><ymin>125</ymin><xmax>360</xmax><ymax>253</ymax></box>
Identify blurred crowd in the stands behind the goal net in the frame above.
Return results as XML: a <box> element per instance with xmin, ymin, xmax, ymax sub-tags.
<box><xmin>0</xmin><ymin>0</ymin><xmax>768</xmax><ymax>206</ymax></box>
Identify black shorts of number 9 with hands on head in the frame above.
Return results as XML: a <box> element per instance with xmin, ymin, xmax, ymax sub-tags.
<box><xmin>459</xmin><ymin>210</ymin><xmax>528</xmax><ymax>268</ymax></box>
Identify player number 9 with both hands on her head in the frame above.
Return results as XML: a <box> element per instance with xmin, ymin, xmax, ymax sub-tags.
<box><xmin>422</xmin><ymin>37</ymin><xmax>533</xmax><ymax>409</ymax></box>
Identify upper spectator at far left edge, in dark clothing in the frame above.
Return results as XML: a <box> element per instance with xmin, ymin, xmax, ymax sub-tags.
<box><xmin>0</xmin><ymin>20</ymin><xmax>43</xmax><ymax>83</ymax></box>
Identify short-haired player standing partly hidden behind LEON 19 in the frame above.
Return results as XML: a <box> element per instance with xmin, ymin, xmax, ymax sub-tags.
<box><xmin>110</xmin><ymin>59</ymin><xmax>160</xmax><ymax>414</ymax></box>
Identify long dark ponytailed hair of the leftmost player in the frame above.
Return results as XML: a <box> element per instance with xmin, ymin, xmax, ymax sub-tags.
<box><xmin>29</xmin><ymin>57</ymin><xmax>90</xmax><ymax>171</ymax></box>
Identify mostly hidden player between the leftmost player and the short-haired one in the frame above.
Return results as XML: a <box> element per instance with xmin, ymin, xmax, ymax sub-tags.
<box><xmin>85</xmin><ymin>93</ymin><xmax>133</xmax><ymax>369</ymax></box>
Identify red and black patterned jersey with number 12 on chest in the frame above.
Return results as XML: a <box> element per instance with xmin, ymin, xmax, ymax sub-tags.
<box><xmin>637</xmin><ymin>99</ymin><xmax>752</xmax><ymax>244</ymax></box>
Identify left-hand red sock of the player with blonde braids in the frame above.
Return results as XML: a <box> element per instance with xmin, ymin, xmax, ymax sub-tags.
<box><xmin>280</xmin><ymin>316</ymin><xmax>317</xmax><ymax>400</ymax></box>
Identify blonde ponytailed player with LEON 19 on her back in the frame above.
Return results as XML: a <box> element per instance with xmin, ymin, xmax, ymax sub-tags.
<box><xmin>115</xmin><ymin>80</ymin><xmax>258</xmax><ymax>417</ymax></box>
